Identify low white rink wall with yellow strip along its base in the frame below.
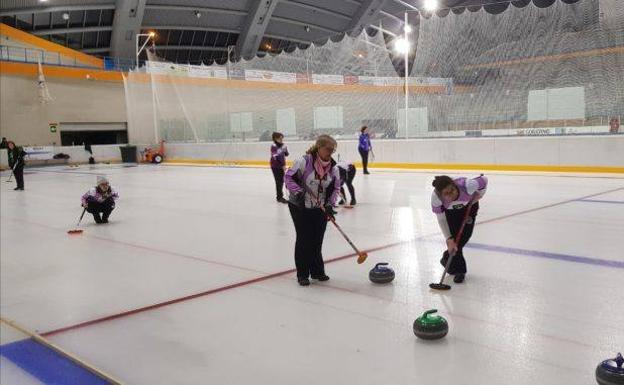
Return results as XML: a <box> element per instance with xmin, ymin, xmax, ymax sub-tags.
<box><xmin>166</xmin><ymin>135</ymin><xmax>624</xmax><ymax>173</ymax></box>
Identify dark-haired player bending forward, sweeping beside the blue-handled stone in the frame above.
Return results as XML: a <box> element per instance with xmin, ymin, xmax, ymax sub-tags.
<box><xmin>431</xmin><ymin>175</ymin><xmax>488</xmax><ymax>283</ymax></box>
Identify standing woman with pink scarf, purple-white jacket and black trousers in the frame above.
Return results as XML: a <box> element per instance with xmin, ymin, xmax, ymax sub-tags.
<box><xmin>285</xmin><ymin>135</ymin><xmax>340</xmax><ymax>286</ymax></box>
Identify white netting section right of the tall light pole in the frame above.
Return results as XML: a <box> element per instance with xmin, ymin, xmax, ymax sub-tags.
<box><xmin>410</xmin><ymin>0</ymin><xmax>624</xmax><ymax>134</ymax></box>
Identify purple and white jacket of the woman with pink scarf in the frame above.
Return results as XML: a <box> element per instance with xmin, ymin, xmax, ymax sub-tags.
<box><xmin>284</xmin><ymin>154</ymin><xmax>340</xmax><ymax>209</ymax></box>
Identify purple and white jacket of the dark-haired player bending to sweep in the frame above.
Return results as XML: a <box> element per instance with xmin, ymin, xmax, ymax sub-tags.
<box><xmin>431</xmin><ymin>175</ymin><xmax>488</xmax><ymax>239</ymax></box>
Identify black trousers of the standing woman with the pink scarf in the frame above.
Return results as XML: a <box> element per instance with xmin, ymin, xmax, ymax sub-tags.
<box><xmin>288</xmin><ymin>203</ymin><xmax>327</xmax><ymax>278</ymax></box>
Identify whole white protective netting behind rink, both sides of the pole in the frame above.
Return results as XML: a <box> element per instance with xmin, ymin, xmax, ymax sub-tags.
<box><xmin>125</xmin><ymin>0</ymin><xmax>624</xmax><ymax>142</ymax></box>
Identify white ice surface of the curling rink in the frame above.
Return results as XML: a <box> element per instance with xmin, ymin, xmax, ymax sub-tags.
<box><xmin>0</xmin><ymin>165</ymin><xmax>624</xmax><ymax>385</ymax></box>
